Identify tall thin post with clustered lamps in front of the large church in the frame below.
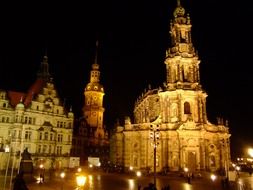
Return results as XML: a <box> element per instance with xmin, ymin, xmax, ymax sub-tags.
<box><xmin>150</xmin><ymin>125</ymin><xmax>160</xmax><ymax>188</ymax></box>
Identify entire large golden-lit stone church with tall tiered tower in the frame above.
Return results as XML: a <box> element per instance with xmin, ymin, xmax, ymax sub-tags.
<box><xmin>110</xmin><ymin>1</ymin><xmax>231</xmax><ymax>172</ymax></box>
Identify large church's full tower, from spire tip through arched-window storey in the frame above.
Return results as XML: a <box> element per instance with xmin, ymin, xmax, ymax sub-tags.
<box><xmin>164</xmin><ymin>0</ymin><xmax>207</xmax><ymax>123</ymax></box>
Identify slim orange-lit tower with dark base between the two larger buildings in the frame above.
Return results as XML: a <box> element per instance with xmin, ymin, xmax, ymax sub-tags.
<box><xmin>72</xmin><ymin>42</ymin><xmax>109</xmax><ymax>165</ymax></box>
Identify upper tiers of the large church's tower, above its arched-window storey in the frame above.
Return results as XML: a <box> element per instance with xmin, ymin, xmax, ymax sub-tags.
<box><xmin>165</xmin><ymin>0</ymin><xmax>200</xmax><ymax>90</ymax></box>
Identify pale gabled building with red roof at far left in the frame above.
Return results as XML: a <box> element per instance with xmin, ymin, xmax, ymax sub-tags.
<box><xmin>0</xmin><ymin>56</ymin><xmax>74</xmax><ymax>169</ymax></box>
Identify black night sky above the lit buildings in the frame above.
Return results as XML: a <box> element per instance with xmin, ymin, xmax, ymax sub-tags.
<box><xmin>0</xmin><ymin>0</ymin><xmax>253</xmax><ymax>158</ymax></box>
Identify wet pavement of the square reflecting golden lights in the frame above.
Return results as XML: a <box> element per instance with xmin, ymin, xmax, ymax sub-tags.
<box><xmin>0</xmin><ymin>172</ymin><xmax>253</xmax><ymax>190</ymax></box>
